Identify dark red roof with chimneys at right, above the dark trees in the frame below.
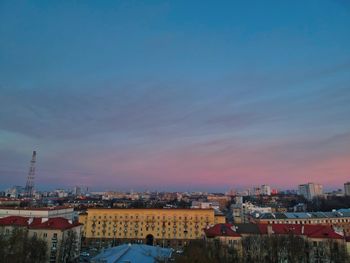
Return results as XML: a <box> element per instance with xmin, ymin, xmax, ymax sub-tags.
<box><xmin>258</xmin><ymin>224</ymin><xmax>344</xmax><ymax>239</ymax></box>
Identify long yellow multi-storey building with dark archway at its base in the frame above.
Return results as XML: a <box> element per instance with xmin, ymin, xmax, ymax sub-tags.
<box><xmin>79</xmin><ymin>208</ymin><xmax>225</xmax><ymax>249</ymax></box>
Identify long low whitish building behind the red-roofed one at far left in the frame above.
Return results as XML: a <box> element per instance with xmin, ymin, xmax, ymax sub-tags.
<box><xmin>0</xmin><ymin>206</ymin><xmax>76</xmax><ymax>220</ymax></box>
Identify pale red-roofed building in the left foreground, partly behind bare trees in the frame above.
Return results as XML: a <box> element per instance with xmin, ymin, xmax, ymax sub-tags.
<box><xmin>0</xmin><ymin>216</ymin><xmax>82</xmax><ymax>263</ymax></box>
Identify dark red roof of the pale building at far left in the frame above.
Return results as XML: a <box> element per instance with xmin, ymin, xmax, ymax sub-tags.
<box><xmin>0</xmin><ymin>216</ymin><xmax>82</xmax><ymax>230</ymax></box>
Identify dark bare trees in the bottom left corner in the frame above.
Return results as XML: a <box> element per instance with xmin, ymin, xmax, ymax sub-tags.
<box><xmin>0</xmin><ymin>229</ymin><xmax>47</xmax><ymax>263</ymax></box>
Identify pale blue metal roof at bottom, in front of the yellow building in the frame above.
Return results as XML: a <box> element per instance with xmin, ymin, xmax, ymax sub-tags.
<box><xmin>90</xmin><ymin>244</ymin><xmax>172</xmax><ymax>263</ymax></box>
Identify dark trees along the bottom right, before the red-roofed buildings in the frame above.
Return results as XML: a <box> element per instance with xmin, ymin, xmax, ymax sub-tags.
<box><xmin>176</xmin><ymin>235</ymin><xmax>350</xmax><ymax>263</ymax></box>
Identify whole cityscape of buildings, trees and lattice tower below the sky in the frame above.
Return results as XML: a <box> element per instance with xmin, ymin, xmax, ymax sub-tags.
<box><xmin>0</xmin><ymin>152</ymin><xmax>350</xmax><ymax>263</ymax></box>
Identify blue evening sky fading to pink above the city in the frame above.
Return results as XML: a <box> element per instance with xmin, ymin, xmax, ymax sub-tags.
<box><xmin>0</xmin><ymin>0</ymin><xmax>350</xmax><ymax>191</ymax></box>
